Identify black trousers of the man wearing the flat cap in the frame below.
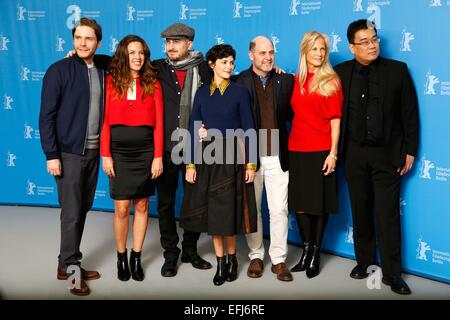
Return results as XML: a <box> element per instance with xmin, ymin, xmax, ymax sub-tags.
<box><xmin>156</xmin><ymin>152</ymin><xmax>200</xmax><ymax>260</ymax></box>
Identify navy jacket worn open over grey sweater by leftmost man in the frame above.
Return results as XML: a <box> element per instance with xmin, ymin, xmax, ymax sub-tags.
<box><xmin>39</xmin><ymin>55</ymin><xmax>105</xmax><ymax>160</ymax></box>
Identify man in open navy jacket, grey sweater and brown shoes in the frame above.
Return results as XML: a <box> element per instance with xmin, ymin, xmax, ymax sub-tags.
<box><xmin>39</xmin><ymin>18</ymin><xmax>105</xmax><ymax>296</ymax></box>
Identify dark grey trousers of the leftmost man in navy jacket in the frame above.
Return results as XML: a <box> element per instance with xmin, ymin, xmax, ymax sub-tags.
<box><xmin>55</xmin><ymin>149</ymin><xmax>100</xmax><ymax>270</ymax></box>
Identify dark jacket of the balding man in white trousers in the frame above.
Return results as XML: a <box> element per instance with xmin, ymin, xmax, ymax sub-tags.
<box><xmin>232</xmin><ymin>66</ymin><xmax>294</xmax><ymax>171</ymax></box>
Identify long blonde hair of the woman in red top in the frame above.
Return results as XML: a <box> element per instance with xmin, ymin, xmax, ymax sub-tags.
<box><xmin>298</xmin><ymin>31</ymin><xmax>340</xmax><ymax>97</ymax></box>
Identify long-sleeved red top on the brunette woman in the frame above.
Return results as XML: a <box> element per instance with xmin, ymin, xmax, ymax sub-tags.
<box><xmin>100</xmin><ymin>76</ymin><xmax>164</xmax><ymax>158</ymax></box>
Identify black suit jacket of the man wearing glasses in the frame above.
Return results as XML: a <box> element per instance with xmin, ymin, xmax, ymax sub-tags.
<box><xmin>334</xmin><ymin>57</ymin><xmax>419</xmax><ymax>167</ymax></box>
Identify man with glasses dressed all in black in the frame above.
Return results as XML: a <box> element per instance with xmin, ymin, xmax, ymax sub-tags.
<box><xmin>335</xmin><ymin>19</ymin><xmax>419</xmax><ymax>294</ymax></box>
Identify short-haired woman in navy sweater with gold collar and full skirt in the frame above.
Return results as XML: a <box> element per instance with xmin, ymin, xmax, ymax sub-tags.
<box><xmin>180</xmin><ymin>44</ymin><xmax>257</xmax><ymax>285</ymax></box>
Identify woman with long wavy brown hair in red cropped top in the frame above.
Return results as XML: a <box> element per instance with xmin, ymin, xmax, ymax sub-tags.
<box><xmin>100</xmin><ymin>35</ymin><xmax>163</xmax><ymax>281</ymax></box>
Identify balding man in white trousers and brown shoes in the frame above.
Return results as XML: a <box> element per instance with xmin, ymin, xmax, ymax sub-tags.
<box><xmin>233</xmin><ymin>36</ymin><xmax>294</xmax><ymax>281</ymax></box>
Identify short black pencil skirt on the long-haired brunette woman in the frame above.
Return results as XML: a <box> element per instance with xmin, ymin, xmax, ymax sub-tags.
<box><xmin>109</xmin><ymin>125</ymin><xmax>155</xmax><ymax>200</ymax></box>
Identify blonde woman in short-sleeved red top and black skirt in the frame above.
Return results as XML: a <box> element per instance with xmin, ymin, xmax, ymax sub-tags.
<box><xmin>288</xmin><ymin>32</ymin><xmax>343</xmax><ymax>278</ymax></box>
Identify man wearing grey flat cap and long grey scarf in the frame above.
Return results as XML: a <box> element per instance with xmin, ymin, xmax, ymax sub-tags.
<box><xmin>152</xmin><ymin>23</ymin><xmax>212</xmax><ymax>277</ymax></box>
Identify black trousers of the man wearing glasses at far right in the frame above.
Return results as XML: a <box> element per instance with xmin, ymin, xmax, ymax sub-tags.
<box><xmin>344</xmin><ymin>141</ymin><xmax>402</xmax><ymax>276</ymax></box>
